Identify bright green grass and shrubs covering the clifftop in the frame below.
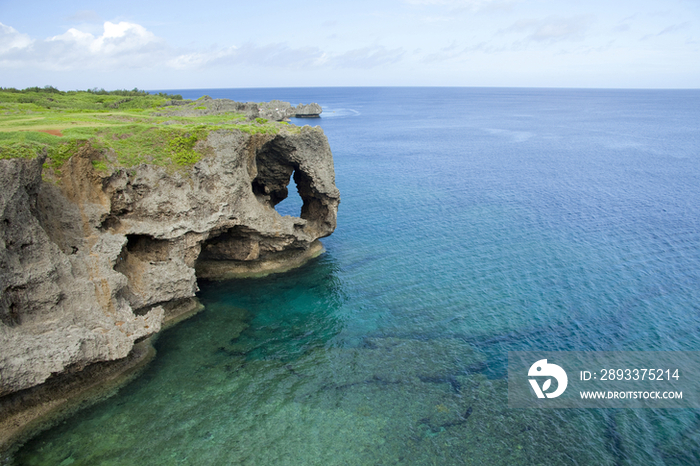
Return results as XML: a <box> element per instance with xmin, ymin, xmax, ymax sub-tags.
<box><xmin>0</xmin><ymin>86</ymin><xmax>290</xmax><ymax>177</ymax></box>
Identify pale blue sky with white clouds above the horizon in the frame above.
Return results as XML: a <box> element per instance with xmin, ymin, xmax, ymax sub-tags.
<box><xmin>0</xmin><ymin>0</ymin><xmax>700</xmax><ymax>90</ymax></box>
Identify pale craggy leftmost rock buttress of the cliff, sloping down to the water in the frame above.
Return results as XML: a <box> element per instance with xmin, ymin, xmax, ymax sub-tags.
<box><xmin>0</xmin><ymin>158</ymin><xmax>163</xmax><ymax>395</ymax></box>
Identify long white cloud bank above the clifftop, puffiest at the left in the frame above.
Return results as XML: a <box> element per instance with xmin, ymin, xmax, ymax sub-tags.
<box><xmin>0</xmin><ymin>21</ymin><xmax>403</xmax><ymax>71</ymax></box>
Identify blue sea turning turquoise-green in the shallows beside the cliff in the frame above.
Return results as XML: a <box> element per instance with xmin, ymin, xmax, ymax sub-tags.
<box><xmin>17</xmin><ymin>88</ymin><xmax>700</xmax><ymax>466</ymax></box>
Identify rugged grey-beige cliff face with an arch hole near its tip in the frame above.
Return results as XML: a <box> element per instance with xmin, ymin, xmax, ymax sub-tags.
<box><xmin>0</xmin><ymin>122</ymin><xmax>340</xmax><ymax>395</ymax></box>
